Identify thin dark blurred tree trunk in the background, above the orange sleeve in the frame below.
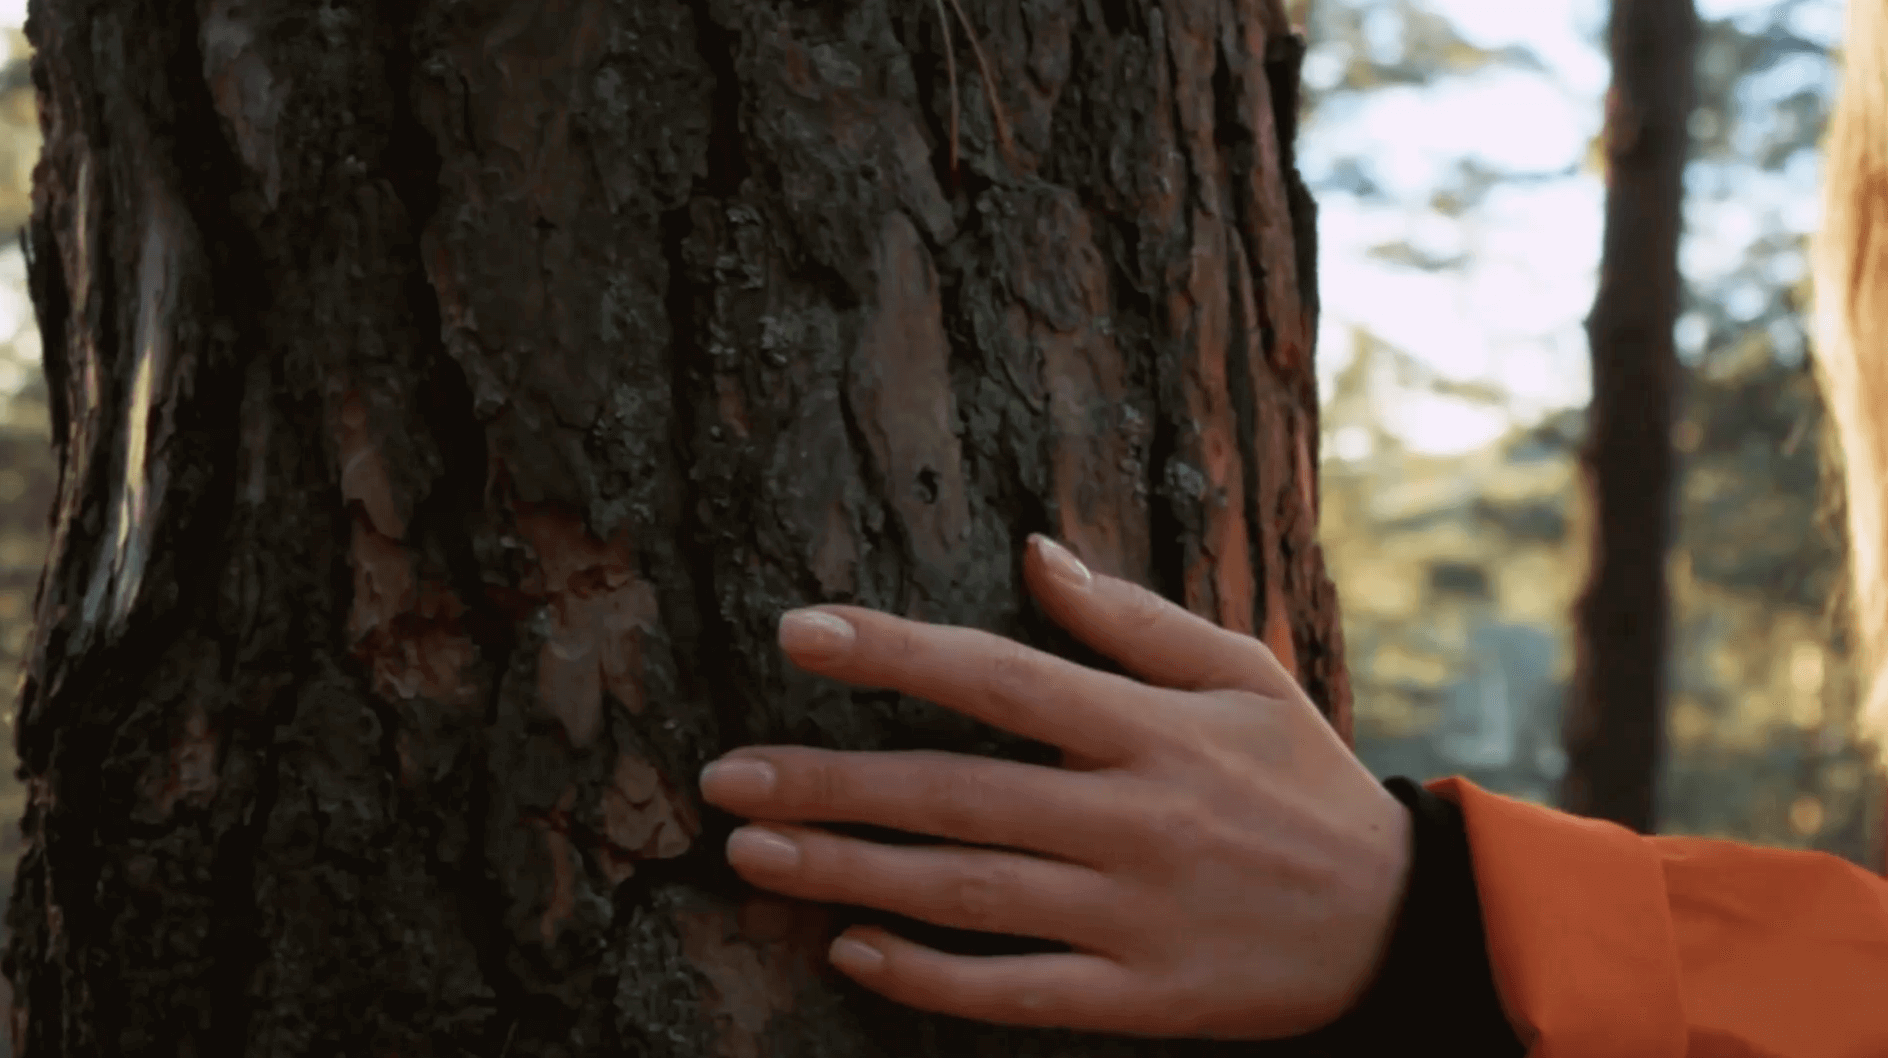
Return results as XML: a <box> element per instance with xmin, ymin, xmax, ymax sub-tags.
<box><xmin>1561</xmin><ymin>0</ymin><xmax>1697</xmax><ymax>833</ymax></box>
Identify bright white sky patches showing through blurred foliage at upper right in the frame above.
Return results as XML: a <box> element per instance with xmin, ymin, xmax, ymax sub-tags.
<box><xmin>1303</xmin><ymin>0</ymin><xmax>1841</xmax><ymax>453</ymax></box>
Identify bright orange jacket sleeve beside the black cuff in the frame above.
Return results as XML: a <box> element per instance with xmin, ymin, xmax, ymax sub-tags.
<box><xmin>1427</xmin><ymin>778</ymin><xmax>1888</xmax><ymax>1058</ymax></box>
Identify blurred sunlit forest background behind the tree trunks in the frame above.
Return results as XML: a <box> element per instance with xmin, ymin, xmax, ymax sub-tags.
<box><xmin>0</xmin><ymin>0</ymin><xmax>1857</xmax><ymax>1047</ymax></box>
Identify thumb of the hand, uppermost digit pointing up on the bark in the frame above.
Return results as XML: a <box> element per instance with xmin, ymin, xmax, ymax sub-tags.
<box><xmin>1023</xmin><ymin>537</ymin><xmax>1299</xmax><ymax>697</ymax></box>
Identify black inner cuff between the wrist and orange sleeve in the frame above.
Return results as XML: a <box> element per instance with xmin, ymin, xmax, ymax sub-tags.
<box><xmin>1267</xmin><ymin>778</ymin><xmax>1526</xmax><ymax>1058</ymax></box>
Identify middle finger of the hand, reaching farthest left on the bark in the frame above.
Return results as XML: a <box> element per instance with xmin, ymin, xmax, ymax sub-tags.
<box><xmin>702</xmin><ymin>746</ymin><xmax>1133</xmax><ymax>865</ymax></box>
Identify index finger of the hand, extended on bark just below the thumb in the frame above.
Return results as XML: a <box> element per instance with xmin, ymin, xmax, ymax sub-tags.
<box><xmin>780</xmin><ymin>606</ymin><xmax>1174</xmax><ymax>765</ymax></box>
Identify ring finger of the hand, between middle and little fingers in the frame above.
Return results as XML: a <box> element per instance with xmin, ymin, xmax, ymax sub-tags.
<box><xmin>727</xmin><ymin>826</ymin><xmax>1121</xmax><ymax>948</ymax></box>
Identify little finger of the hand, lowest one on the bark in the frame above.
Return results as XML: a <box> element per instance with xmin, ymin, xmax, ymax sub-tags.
<box><xmin>833</xmin><ymin>928</ymin><xmax>1161</xmax><ymax>1035</ymax></box>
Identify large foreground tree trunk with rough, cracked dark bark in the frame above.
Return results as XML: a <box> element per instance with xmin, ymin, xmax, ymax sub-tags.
<box><xmin>6</xmin><ymin>0</ymin><xmax>1348</xmax><ymax>1058</ymax></box>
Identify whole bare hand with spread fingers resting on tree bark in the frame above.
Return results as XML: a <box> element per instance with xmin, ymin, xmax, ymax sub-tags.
<box><xmin>702</xmin><ymin>537</ymin><xmax>1410</xmax><ymax>1039</ymax></box>
